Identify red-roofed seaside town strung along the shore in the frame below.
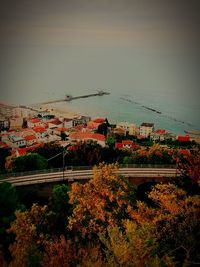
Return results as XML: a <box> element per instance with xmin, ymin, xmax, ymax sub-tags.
<box><xmin>0</xmin><ymin>103</ymin><xmax>200</xmax><ymax>173</ymax></box>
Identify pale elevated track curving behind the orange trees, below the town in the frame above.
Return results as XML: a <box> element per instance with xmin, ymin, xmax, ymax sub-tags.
<box><xmin>0</xmin><ymin>168</ymin><xmax>178</xmax><ymax>186</ymax></box>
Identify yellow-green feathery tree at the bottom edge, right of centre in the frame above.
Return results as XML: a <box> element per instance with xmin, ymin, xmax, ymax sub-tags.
<box><xmin>100</xmin><ymin>220</ymin><xmax>173</xmax><ymax>267</ymax></box>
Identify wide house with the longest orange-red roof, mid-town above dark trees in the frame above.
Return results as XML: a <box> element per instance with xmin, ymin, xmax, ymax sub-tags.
<box><xmin>69</xmin><ymin>132</ymin><xmax>105</xmax><ymax>147</ymax></box>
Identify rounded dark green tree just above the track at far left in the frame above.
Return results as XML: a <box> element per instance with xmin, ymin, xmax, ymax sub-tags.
<box><xmin>13</xmin><ymin>153</ymin><xmax>48</xmax><ymax>172</ymax></box>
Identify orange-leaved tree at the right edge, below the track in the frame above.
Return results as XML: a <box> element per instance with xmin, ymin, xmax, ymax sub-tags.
<box><xmin>130</xmin><ymin>184</ymin><xmax>200</xmax><ymax>266</ymax></box>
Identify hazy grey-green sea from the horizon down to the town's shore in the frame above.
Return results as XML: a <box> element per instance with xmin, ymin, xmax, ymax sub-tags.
<box><xmin>0</xmin><ymin>46</ymin><xmax>200</xmax><ymax>134</ymax></box>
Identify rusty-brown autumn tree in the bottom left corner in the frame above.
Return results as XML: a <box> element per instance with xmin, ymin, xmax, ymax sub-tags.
<box><xmin>8</xmin><ymin>204</ymin><xmax>54</xmax><ymax>267</ymax></box>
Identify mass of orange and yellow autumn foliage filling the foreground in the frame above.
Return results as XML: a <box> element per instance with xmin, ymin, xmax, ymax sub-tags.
<box><xmin>4</xmin><ymin>158</ymin><xmax>200</xmax><ymax>267</ymax></box>
